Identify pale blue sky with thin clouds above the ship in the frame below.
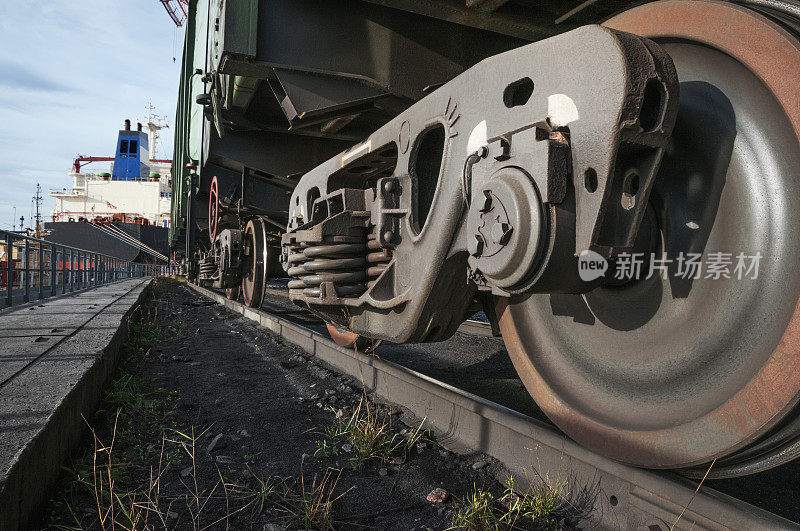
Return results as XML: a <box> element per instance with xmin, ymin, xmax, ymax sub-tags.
<box><xmin>0</xmin><ymin>0</ymin><xmax>183</xmax><ymax>229</ymax></box>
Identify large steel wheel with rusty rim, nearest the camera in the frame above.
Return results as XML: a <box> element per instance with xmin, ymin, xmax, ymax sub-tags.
<box><xmin>497</xmin><ymin>0</ymin><xmax>800</xmax><ymax>477</ymax></box>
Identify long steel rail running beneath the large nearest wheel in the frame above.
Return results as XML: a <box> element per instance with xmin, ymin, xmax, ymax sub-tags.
<box><xmin>189</xmin><ymin>284</ymin><xmax>800</xmax><ymax>531</ymax></box>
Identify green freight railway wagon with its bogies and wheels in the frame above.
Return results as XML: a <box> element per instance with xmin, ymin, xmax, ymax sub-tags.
<box><xmin>172</xmin><ymin>0</ymin><xmax>800</xmax><ymax>477</ymax></box>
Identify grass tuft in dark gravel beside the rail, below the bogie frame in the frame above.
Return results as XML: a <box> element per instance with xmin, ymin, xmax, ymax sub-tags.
<box><xmin>315</xmin><ymin>396</ymin><xmax>425</xmax><ymax>469</ymax></box>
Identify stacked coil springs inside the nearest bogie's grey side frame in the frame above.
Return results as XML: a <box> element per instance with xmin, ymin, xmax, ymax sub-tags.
<box><xmin>287</xmin><ymin>233</ymin><xmax>391</xmax><ymax>298</ymax></box>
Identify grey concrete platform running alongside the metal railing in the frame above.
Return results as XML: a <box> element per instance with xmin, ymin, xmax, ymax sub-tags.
<box><xmin>0</xmin><ymin>277</ymin><xmax>150</xmax><ymax>530</ymax></box>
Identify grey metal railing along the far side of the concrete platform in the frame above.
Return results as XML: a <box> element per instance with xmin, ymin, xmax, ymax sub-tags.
<box><xmin>0</xmin><ymin>229</ymin><xmax>171</xmax><ymax>308</ymax></box>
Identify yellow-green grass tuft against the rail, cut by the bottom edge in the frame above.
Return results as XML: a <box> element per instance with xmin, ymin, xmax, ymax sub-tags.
<box><xmin>450</xmin><ymin>477</ymin><xmax>565</xmax><ymax>531</ymax></box>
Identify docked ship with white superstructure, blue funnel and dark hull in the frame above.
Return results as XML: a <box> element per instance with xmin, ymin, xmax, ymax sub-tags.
<box><xmin>44</xmin><ymin>114</ymin><xmax>172</xmax><ymax>263</ymax></box>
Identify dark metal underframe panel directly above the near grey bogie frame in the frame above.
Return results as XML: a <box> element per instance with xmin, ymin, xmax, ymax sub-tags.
<box><xmin>256</xmin><ymin>0</ymin><xmax>523</xmax><ymax>100</ymax></box>
